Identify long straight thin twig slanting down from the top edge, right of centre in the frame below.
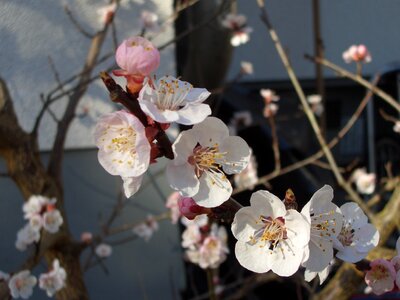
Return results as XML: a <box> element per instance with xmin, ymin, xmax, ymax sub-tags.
<box><xmin>257</xmin><ymin>0</ymin><xmax>373</xmax><ymax>221</ymax></box>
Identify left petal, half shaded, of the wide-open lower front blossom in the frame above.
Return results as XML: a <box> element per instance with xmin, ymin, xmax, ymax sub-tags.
<box><xmin>231</xmin><ymin>207</ymin><xmax>262</xmax><ymax>242</ymax></box>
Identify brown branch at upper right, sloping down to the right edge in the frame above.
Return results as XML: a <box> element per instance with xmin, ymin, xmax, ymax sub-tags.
<box><xmin>305</xmin><ymin>54</ymin><xmax>400</xmax><ymax>112</ymax></box>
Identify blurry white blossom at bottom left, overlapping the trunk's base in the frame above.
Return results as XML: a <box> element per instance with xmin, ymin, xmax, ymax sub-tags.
<box><xmin>39</xmin><ymin>259</ymin><xmax>67</xmax><ymax>297</ymax></box>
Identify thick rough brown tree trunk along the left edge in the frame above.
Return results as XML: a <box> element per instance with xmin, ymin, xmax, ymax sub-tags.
<box><xmin>0</xmin><ymin>79</ymin><xmax>88</xmax><ymax>300</ymax></box>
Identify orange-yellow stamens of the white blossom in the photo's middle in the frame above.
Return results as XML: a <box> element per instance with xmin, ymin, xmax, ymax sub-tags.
<box><xmin>188</xmin><ymin>143</ymin><xmax>226</xmax><ymax>178</ymax></box>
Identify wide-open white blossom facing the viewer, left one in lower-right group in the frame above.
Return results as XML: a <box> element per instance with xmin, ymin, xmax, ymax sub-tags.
<box><xmin>232</xmin><ymin>191</ymin><xmax>310</xmax><ymax>276</ymax></box>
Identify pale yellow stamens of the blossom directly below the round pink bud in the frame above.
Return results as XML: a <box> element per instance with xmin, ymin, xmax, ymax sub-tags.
<box><xmin>155</xmin><ymin>79</ymin><xmax>192</xmax><ymax>110</ymax></box>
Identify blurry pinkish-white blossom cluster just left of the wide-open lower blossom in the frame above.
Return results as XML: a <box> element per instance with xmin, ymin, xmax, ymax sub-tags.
<box><xmin>182</xmin><ymin>215</ymin><xmax>229</xmax><ymax>269</ymax></box>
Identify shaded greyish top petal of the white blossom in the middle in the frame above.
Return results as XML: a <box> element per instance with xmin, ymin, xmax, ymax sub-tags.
<box><xmin>192</xmin><ymin>117</ymin><xmax>229</xmax><ymax>147</ymax></box>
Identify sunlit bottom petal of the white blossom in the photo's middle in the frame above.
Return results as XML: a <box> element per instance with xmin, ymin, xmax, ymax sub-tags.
<box><xmin>193</xmin><ymin>171</ymin><xmax>232</xmax><ymax>207</ymax></box>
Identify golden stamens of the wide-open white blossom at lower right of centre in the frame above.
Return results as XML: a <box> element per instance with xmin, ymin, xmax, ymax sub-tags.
<box><xmin>250</xmin><ymin>216</ymin><xmax>287</xmax><ymax>250</ymax></box>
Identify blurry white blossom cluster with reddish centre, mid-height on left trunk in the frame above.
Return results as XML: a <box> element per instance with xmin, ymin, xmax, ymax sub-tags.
<box><xmin>15</xmin><ymin>195</ymin><xmax>63</xmax><ymax>251</ymax></box>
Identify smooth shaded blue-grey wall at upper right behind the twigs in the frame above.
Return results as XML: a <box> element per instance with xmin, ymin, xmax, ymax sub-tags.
<box><xmin>230</xmin><ymin>0</ymin><xmax>400</xmax><ymax>80</ymax></box>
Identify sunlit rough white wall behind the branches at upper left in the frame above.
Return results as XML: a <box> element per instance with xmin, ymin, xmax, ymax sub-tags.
<box><xmin>0</xmin><ymin>0</ymin><xmax>175</xmax><ymax>149</ymax></box>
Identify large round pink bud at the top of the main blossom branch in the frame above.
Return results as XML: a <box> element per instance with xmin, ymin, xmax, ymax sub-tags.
<box><xmin>114</xmin><ymin>36</ymin><xmax>160</xmax><ymax>76</ymax></box>
